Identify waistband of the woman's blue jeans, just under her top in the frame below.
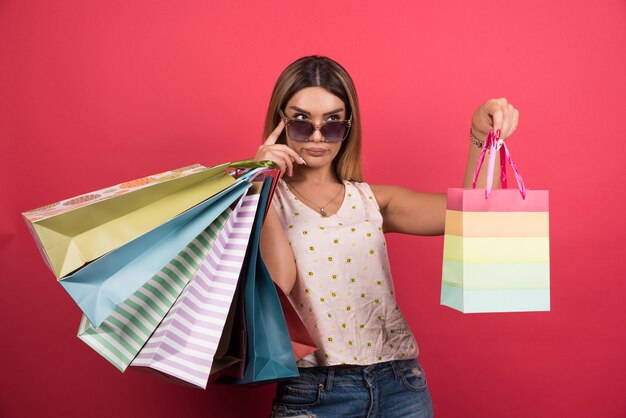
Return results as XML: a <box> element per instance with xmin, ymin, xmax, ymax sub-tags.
<box><xmin>279</xmin><ymin>359</ymin><xmax>418</xmax><ymax>390</ymax></box>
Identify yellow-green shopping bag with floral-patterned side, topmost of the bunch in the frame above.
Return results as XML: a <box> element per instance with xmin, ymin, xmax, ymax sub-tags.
<box><xmin>23</xmin><ymin>164</ymin><xmax>235</xmax><ymax>279</ymax></box>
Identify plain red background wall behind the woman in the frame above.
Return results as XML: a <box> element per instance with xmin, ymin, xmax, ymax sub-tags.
<box><xmin>0</xmin><ymin>0</ymin><xmax>626</xmax><ymax>418</ymax></box>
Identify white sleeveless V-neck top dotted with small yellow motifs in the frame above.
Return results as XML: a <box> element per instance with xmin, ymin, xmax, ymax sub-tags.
<box><xmin>273</xmin><ymin>179</ymin><xmax>418</xmax><ymax>367</ymax></box>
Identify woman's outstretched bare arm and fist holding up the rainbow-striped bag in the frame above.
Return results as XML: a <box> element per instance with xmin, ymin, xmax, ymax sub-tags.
<box><xmin>371</xmin><ymin>98</ymin><xmax>519</xmax><ymax>235</ymax></box>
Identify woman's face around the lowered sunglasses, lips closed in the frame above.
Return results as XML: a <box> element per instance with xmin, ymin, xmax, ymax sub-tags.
<box><xmin>285</xmin><ymin>87</ymin><xmax>346</xmax><ymax>168</ymax></box>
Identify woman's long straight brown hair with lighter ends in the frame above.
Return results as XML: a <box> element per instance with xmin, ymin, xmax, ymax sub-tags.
<box><xmin>263</xmin><ymin>55</ymin><xmax>363</xmax><ymax>181</ymax></box>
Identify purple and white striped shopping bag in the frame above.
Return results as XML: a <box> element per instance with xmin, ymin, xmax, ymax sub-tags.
<box><xmin>131</xmin><ymin>193</ymin><xmax>259</xmax><ymax>388</ymax></box>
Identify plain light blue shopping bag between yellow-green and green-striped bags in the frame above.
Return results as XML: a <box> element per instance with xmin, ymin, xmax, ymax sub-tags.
<box><xmin>59</xmin><ymin>181</ymin><xmax>250</xmax><ymax>327</ymax></box>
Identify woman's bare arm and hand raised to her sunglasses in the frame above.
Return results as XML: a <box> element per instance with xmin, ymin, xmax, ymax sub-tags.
<box><xmin>254</xmin><ymin>121</ymin><xmax>304</xmax><ymax>295</ymax></box>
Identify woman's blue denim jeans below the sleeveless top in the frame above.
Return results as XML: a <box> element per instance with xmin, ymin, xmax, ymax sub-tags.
<box><xmin>272</xmin><ymin>359</ymin><xmax>433</xmax><ymax>418</ymax></box>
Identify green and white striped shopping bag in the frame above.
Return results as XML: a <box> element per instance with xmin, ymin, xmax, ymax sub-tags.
<box><xmin>78</xmin><ymin>208</ymin><xmax>232</xmax><ymax>372</ymax></box>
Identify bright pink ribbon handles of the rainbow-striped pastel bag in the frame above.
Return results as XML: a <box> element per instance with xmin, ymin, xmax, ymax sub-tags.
<box><xmin>472</xmin><ymin>129</ymin><xmax>526</xmax><ymax>199</ymax></box>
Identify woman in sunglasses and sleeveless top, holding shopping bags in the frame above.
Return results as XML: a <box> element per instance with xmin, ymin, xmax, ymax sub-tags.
<box><xmin>255</xmin><ymin>56</ymin><xmax>518</xmax><ymax>417</ymax></box>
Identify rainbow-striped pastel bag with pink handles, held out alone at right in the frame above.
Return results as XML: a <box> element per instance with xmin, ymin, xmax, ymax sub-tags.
<box><xmin>441</xmin><ymin>132</ymin><xmax>550</xmax><ymax>313</ymax></box>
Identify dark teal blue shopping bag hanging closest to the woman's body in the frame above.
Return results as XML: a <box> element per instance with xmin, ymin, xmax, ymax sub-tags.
<box><xmin>234</xmin><ymin>178</ymin><xmax>299</xmax><ymax>384</ymax></box>
